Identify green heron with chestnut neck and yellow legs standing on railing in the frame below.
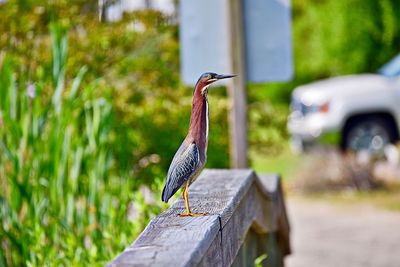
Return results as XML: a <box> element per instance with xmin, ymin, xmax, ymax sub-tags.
<box><xmin>161</xmin><ymin>72</ymin><xmax>235</xmax><ymax>216</ymax></box>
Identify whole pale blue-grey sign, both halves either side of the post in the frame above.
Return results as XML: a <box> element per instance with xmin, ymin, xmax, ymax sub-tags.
<box><xmin>180</xmin><ymin>0</ymin><xmax>293</xmax><ymax>85</ymax></box>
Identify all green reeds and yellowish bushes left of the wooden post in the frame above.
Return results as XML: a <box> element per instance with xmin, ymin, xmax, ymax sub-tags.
<box><xmin>0</xmin><ymin>0</ymin><xmax>228</xmax><ymax>266</ymax></box>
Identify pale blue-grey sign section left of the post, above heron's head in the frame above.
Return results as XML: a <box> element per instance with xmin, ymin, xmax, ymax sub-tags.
<box><xmin>179</xmin><ymin>0</ymin><xmax>231</xmax><ymax>85</ymax></box>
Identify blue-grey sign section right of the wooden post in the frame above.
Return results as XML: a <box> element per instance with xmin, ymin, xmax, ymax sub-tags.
<box><xmin>243</xmin><ymin>0</ymin><xmax>293</xmax><ymax>82</ymax></box>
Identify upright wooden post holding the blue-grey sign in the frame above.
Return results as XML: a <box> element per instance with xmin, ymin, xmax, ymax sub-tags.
<box><xmin>228</xmin><ymin>0</ymin><xmax>248</xmax><ymax>168</ymax></box>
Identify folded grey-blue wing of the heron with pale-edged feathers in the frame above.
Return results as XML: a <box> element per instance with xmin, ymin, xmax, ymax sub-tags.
<box><xmin>162</xmin><ymin>143</ymin><xmax>200</xmax><ymax>202</ymax></box>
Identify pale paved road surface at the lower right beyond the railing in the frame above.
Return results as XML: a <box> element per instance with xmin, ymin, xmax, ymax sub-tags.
<box><xmin>286</xmin><ymin>198</ymin><xmax>400</xmax><ymax>267</ymax></box>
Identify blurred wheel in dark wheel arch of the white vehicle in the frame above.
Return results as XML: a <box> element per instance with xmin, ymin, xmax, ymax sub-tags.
<box><xmin>344</xmin><ymin>117</ymin><xmax>394</xmax><ymax>154</ymax></box>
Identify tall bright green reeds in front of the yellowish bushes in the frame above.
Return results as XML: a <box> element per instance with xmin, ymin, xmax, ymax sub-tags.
<box><xmin>0</xmin><ymin>24</ymin><xmax>166</xmax><ymax>266</ymax></box>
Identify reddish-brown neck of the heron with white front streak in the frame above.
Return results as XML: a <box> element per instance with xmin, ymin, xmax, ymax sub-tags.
<box><xmin>189</xmin><ymin>90</ymin><xmax>209</xmax><ymax>155</ymax></box>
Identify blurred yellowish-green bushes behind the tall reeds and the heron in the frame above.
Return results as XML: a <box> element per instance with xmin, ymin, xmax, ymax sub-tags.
<box><xmin>0</xmin><ymin>0</ymin><xmax>228</xmax><ymax>185</ymax></box>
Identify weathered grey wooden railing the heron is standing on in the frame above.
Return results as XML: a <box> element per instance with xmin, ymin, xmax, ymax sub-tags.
<box><xmin>108</xmin><ymin>170</ymin><xmax>290</xmax><ymax>267</ymax></box>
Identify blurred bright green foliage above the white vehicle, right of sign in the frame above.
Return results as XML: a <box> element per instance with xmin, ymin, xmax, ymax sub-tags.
<box><xmin>293</xmin><ymin>0</ymin><xmax>400</xmax><ymax>79</ymax></box>
